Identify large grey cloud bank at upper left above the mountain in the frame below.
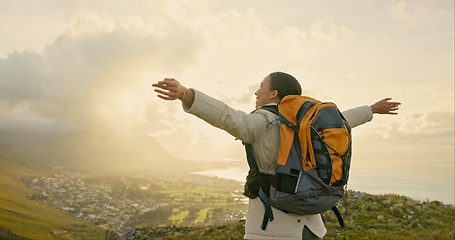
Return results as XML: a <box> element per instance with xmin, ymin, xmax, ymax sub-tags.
<box><xmin>0</xmin><ymin>12</ymin><xmax>204</xmax><ymax>132</ymax></box>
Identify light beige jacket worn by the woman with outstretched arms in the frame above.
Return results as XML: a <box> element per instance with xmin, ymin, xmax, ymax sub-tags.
<box><xmin>183</xmin><ymin>89</ymin><xmax>373</xmax><ymax>239</ymax></box>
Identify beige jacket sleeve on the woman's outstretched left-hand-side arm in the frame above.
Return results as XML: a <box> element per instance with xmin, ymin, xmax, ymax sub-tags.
<box><xmin>183</xmin><ymin>89</ymin><xmax>270</xmax><ymax>143</ymax></box>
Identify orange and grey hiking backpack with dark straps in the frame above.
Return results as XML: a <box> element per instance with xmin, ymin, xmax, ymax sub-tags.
<box><xmin>244</xmin><ymin>95</ymin><xmax>352</xmax><ymax>230</ymax></box>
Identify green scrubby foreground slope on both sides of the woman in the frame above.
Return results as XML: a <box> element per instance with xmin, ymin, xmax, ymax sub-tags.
<box><xmin>135</xmin><ymin>192</ymin><xmax>455</xmax><ymax>240</ymax></box>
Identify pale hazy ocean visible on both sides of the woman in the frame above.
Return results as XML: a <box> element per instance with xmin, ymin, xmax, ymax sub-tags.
<box><xmin>195</xmin><ymin>162</ymin><xmax>455</xmax><ymax>204</ymax></box>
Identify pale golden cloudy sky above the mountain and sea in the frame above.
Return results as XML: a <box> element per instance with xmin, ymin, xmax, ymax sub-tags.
<box><xmin>0</xmin><ymin>0</ymin><xmax>455</xmax><ymax>203</ymax></box>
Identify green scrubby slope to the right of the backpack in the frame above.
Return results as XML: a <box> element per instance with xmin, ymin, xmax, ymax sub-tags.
<box><xmin>324</xmin><ymin>191</ymin><xmax>455</xmax><ymax>240</ymax></box>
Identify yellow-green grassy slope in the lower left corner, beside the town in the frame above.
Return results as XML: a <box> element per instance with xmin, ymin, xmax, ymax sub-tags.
<box><xmin>0</xmin><ymin>156</ymin><xmax>104</xmax><ymax>240</ymax></box>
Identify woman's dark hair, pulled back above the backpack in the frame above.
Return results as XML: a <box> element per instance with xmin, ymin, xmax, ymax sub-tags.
<box><xmin>269</xmin><ymin>72</ymin><xmax>302</xmax><ymax>100</ymax></box>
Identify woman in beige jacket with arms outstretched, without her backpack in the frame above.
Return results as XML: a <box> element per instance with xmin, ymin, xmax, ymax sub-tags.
<box><xmin>153</xmin><ymin>72</ymin><xmax>400</xmax><ymax>240</ymax></box>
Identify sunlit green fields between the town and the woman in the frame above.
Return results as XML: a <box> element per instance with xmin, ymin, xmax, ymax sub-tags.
<box><xmin>131</xmin><ymin>173</ymin><xmax>246</xmax><ymax>227</ymax></box>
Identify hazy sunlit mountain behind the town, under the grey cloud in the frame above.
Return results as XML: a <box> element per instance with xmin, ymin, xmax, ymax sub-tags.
<box><xmin>0</xmin><ymin>129</ymin><xmax>232</xmax><ymax>172</ymax></box>
